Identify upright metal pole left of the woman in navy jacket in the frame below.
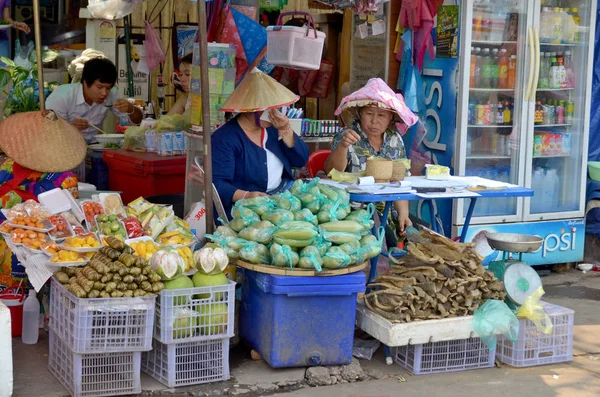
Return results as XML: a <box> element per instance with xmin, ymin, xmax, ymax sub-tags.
<box><xmin>198</xmin><ymin>1</ymin><xmax>214</xmax><ymax>233</ymax></box>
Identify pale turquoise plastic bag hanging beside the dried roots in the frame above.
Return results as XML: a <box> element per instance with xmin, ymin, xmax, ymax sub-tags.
<box><xmin>473</xmin><ymin>299</ymin><xmax>519</xmax><ymax>349</ymax></box>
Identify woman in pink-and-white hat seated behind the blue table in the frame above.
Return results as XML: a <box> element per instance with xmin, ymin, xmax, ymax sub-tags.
<box><xmin>325</xmin><ymin>79</ymin><xmax>418</xmax><ymax>238</ymax></box>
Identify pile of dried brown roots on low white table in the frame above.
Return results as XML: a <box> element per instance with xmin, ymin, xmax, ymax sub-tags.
<box><xmin>364</xmin><ymin>231</ymin><xmax>506</xmax><ymax>323</ymax></box>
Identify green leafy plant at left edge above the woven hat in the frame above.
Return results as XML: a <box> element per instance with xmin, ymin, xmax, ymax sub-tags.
<box><xmin>0</xmin><ymin>50</ymin><xmax>60</xmax><ymax>118</ymax></box>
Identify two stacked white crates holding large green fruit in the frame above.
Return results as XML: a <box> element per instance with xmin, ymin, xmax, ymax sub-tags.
<box><xmin>142</xmin><ymin>281</ymin><xmax>235</xmax><ymax>388</ymax></box>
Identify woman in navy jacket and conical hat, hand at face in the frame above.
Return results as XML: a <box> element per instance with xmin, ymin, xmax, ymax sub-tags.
<box><xmin>212</xmin><ymin>69</ymin><xmax>309</xmax><ymax>215</ymax></box>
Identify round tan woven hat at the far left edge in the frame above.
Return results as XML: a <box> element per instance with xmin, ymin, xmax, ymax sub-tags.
<box><xmin>0</xmin><ymin>111</ymin><xmax>87</xmax><ymax>172</ymax></box>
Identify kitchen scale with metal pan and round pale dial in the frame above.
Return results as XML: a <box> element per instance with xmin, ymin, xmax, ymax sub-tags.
<box><xmin>487</xmin><ymin>233</ymin><xmax>543</xmax><ymax>310</ymax></box>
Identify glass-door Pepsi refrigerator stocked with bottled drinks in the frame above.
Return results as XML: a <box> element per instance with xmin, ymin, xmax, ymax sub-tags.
<box><xmin>453</xmin><ymin>0</ymin><xmax>596</xmax><ymax>265</ymax></box>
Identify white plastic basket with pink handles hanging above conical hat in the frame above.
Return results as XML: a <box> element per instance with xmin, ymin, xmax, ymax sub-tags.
<box><xmin>267</xmin><ymin>12</ymin><xmax>325</xmax><ymax>70</ymax></box>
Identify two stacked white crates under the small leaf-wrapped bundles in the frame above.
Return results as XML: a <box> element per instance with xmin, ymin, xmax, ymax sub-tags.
<box><xmin>48</xmin><ymin>279</ymin><xmax>156</xmax><ymax>397</ymax></box>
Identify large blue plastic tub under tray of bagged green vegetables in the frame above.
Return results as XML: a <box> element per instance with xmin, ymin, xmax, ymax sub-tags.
<box><xmin>240</xmin><ymin>270</ymin><xmax>366</xmax><ymax>368</ymax></box>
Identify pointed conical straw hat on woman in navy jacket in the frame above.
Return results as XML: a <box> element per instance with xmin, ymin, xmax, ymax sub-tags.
<box><xmin>219</xmin><ymin>68</ymin><xmax>300</xmax><ymax>113</ymax></box>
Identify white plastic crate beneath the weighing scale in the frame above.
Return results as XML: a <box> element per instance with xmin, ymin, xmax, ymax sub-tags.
<box><xmin>496</xmin><ymin>302</ymin><xmax>575</xmax><ymax>367</ymax></box>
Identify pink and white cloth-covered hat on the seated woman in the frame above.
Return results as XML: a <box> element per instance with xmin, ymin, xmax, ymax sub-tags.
<box><xmin>335</xmin><ymin>78</ymin><xmax>419</xmax><ymax>127</ymax></box>
